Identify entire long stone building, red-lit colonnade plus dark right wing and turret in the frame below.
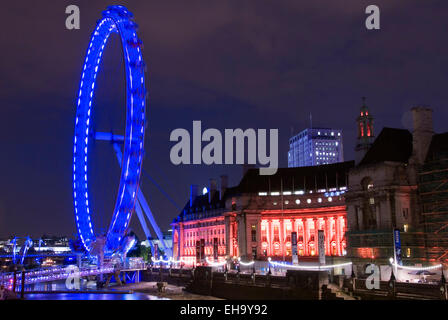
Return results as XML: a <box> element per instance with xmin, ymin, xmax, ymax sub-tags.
<box><xmin>172</xmin><ymin>104</ymin><xmax>448</xmax><ymax>281</ymax></box>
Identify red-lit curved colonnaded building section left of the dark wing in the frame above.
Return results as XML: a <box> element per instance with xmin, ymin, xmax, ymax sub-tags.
<box><xmin>172</xmin><ymin>162</ymin><xmax>354</xmax><ymax>264</ymax></box>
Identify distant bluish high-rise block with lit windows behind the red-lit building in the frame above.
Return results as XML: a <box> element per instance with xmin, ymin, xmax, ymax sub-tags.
<box><xmin>288</xmin><ymin>128</ymin><xmax>344</xmax><ymax>168</ymax></box>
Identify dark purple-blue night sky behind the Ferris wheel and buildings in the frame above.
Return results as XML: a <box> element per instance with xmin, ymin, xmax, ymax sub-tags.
<box><xmin>0</xmin><ymin>0</ymin><xmax>448</xmax><ymax>237</ymax></box>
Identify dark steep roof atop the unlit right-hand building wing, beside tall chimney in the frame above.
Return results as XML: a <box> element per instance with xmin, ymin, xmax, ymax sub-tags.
<box><xmin>360</xmin><ymin>128</ymin><xmax>412</xmax><ymax>165</ymax></box>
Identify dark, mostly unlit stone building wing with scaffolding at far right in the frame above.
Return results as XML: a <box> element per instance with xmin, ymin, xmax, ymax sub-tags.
<box><xmin>346</xmin><ymin>107</ymin><xmax>448</xmax><ymax>280</ymax></box>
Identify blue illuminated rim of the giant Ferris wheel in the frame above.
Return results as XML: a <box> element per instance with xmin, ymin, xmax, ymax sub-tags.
<box><xmin>73</xmin><ymin>6</ymin><xmax>146</xmax><ymax>253</ymax></box>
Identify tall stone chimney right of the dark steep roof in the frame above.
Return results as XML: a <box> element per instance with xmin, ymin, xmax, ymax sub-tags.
<box><xmin>411</xmin><ymin>107</ymin><xmax>434</xmax><ymax>164</ymax></box>
